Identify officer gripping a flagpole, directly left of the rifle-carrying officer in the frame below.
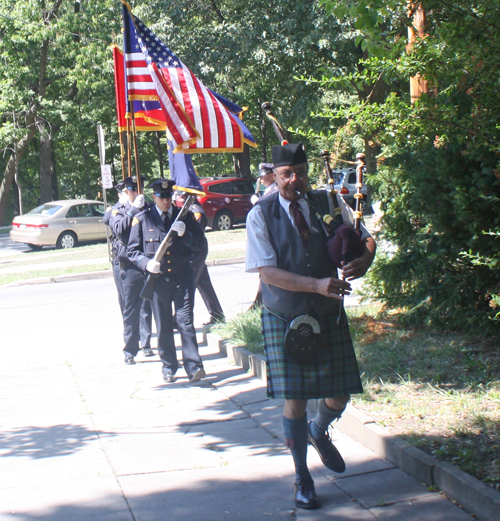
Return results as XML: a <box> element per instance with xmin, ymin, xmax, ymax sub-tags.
<box><xmin>105</xmin><ymin>176</ymin><xmax>154</xmax><ymax>365</ymax></box>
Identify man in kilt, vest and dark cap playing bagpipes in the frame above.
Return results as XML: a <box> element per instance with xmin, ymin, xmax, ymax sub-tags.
<box><xmin>246</xmin><ymin>143</ymin><xmax>376</xmax><ymax>509</ymax></box>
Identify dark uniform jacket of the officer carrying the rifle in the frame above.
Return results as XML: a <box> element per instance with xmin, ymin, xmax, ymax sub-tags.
<box><xmin>127</xmin><ymin>205</ymin><xmax>204</xmax><ymax>279</ymax></box>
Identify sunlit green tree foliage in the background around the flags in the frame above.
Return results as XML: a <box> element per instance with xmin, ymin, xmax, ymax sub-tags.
<box><xmin>0</xmin><ymin>0</ymin><xmax>362</xmax><ymax>221</ymax></box>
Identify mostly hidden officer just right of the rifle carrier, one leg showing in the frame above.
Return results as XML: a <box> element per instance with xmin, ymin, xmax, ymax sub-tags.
<box><xmin>190</xmin><ymin>203</ymin><xmax>225</xmax><ymax>325</ymax></box>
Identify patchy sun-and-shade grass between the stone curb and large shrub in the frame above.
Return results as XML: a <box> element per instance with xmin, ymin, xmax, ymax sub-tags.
<box><xmin>351</xmin><ymin>304</ymin><xmax>500</xmax><ymax>489</ymax></box>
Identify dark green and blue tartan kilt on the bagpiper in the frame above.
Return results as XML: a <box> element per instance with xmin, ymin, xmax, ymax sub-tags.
<box><xmin>262</xmin><ymin>308</ymin><xmax>363</xmax><ymax>400</ymax></box>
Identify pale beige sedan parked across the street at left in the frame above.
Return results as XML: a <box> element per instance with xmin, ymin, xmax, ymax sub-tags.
<box><xmin>10</xmin><ymin>199</ymin><xmax>106</xmax><ymax>250</ymax></box>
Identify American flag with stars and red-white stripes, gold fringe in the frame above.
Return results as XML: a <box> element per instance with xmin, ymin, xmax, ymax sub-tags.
<box><xmin>123</xmin><ymin>3</ymin><xmax>256</xmax><ymax>154</ymax></box>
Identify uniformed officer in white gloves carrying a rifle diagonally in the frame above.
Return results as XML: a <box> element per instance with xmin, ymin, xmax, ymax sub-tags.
<box><xmin>127</xmin><ymin>179</ymin><xmax>205</xmax><ymax>382</ymax></box>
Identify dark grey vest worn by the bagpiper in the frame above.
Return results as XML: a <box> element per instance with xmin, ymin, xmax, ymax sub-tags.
<box><xmin>257</xmin><ymin>193</ymin><xmax>338</xmax><ymax>320</ymax></box>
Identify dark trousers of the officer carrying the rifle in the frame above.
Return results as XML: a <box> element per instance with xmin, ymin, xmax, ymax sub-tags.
<box><xmin>152</xmin><ymin>273</ymin><xmax>203</xmax><ymax>376</ymax></box>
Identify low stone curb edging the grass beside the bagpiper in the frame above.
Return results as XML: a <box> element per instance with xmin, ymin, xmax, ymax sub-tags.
<box><xmin>207</xmin><ymin>332</ymin><xmax>500</xmax><ymax>521</ymax></box>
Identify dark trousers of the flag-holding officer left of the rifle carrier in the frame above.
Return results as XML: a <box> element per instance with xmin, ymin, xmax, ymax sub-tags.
<box><xmin>120</xmin><ymin>264</ymin><xmax>152</xmax><ymax>356</ymax></box>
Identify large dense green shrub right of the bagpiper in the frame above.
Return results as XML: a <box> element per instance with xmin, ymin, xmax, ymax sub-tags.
<box><xmin>320</xmin><ymin>0</ymin><xmax>500</xmax><ymax>334</ymax></box>
